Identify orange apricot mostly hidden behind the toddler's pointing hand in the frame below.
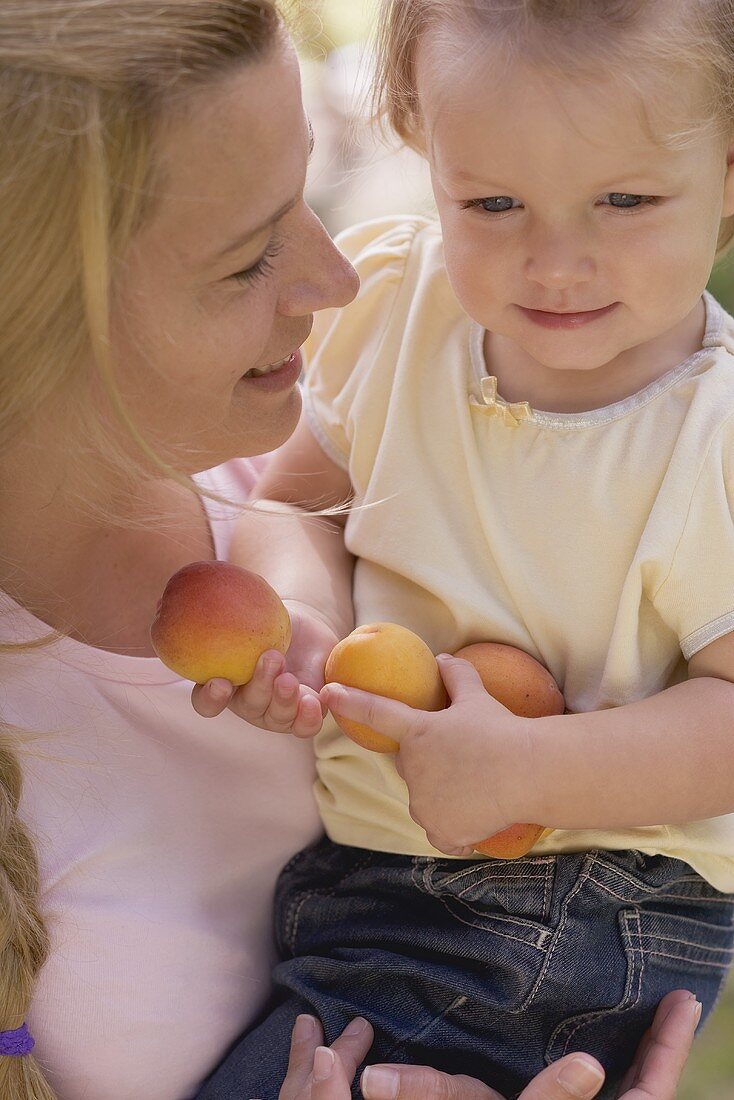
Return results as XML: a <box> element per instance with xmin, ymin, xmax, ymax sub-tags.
<box><xmin>454</xmin><ymin>641</ymin><xmax>566</xmax><ymax>859</ymax></box>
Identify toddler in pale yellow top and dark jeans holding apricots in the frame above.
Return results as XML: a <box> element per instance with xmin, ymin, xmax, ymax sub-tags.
<box><xmin>202</xmin><ymin>0</ymin><xmax>734</xmax><ymax>1100</ymax></box>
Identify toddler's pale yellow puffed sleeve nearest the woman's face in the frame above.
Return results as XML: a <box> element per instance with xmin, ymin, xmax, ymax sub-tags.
<box><xmin>304</xmin><ymin>218</ymin><xmax>427</xmax><ymax>469</ymax></box>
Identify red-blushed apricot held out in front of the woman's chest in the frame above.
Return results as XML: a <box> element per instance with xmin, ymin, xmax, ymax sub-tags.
<box><xmin>151</xmin><ymin>561</ymin><xmax>291</xmax><ymax>685</ymax></box>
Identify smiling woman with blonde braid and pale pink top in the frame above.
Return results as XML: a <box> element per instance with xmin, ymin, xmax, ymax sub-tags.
<box><xmin>0</xmin><ymin>0</ymin><xmax>699</xmax><ymax>1100</ymax></box>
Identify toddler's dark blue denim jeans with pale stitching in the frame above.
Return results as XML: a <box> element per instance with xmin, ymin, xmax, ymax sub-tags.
<box><xmin>194</xmin><ymin>839</ymin><xmax>734</xmax><ymax>1100</ymax></box>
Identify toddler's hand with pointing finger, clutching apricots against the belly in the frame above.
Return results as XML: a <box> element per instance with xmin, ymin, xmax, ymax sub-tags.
<box><xmin>321</xmin><ymin>656</ymin><xmax>543</xmax><ymax>856</ymax></box>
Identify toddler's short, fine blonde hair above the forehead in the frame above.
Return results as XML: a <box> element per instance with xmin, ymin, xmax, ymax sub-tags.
<box><xmin>374</xmin><ymin>0</ymin><xmax>734</xmax><ymax>251</ymax></box>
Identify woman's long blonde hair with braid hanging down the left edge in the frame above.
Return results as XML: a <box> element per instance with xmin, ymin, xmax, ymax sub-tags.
<box><xmin>0</xmin><ymin>0</ymin><xmax>281</xmax><ymax>1100</ymax></box>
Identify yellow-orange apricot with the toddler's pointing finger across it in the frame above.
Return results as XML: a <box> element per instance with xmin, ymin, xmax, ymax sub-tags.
<box><xmin>325</xmin><ymin>623</ymin><xmax>446</xmax><ymax>752</ymax></box>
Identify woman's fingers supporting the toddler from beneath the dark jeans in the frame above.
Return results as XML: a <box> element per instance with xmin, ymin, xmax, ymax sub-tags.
<box><xmin>280</xmin><ymin>989</ymin><xmax>701</xmax><ymax>1100</ymax></box>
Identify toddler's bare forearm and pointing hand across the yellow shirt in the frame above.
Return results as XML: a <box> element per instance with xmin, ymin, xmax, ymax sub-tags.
<box><xmin>322</xmin><ymin>635</ymin><xmax>734</xmax><ymax>854</ymax></box>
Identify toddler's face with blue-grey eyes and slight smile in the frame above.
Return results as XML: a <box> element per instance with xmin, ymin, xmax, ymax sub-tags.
<box><xmin>418</xmin><ymin>30</ymin><xmax>734</xmax><ymax>371</ymax></box>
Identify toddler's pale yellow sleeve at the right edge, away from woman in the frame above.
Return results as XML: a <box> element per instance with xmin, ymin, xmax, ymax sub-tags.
<box><xmin>653</xmin><ymin>418</ymin><xmax>734</xmax><ymax>660</ymax></box>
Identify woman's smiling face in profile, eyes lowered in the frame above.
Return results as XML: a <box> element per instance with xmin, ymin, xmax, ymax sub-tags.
<box><xmin>111</xmin><ymin>33</ymin><xmax>358</xmax><ymax>473</ymax></box>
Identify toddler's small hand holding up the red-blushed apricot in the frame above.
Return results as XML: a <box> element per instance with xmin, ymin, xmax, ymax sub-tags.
<box><xmin>191</xmin><ymin>600</ymin><xmax>339</xmax><ymax>737</ymax></box>
